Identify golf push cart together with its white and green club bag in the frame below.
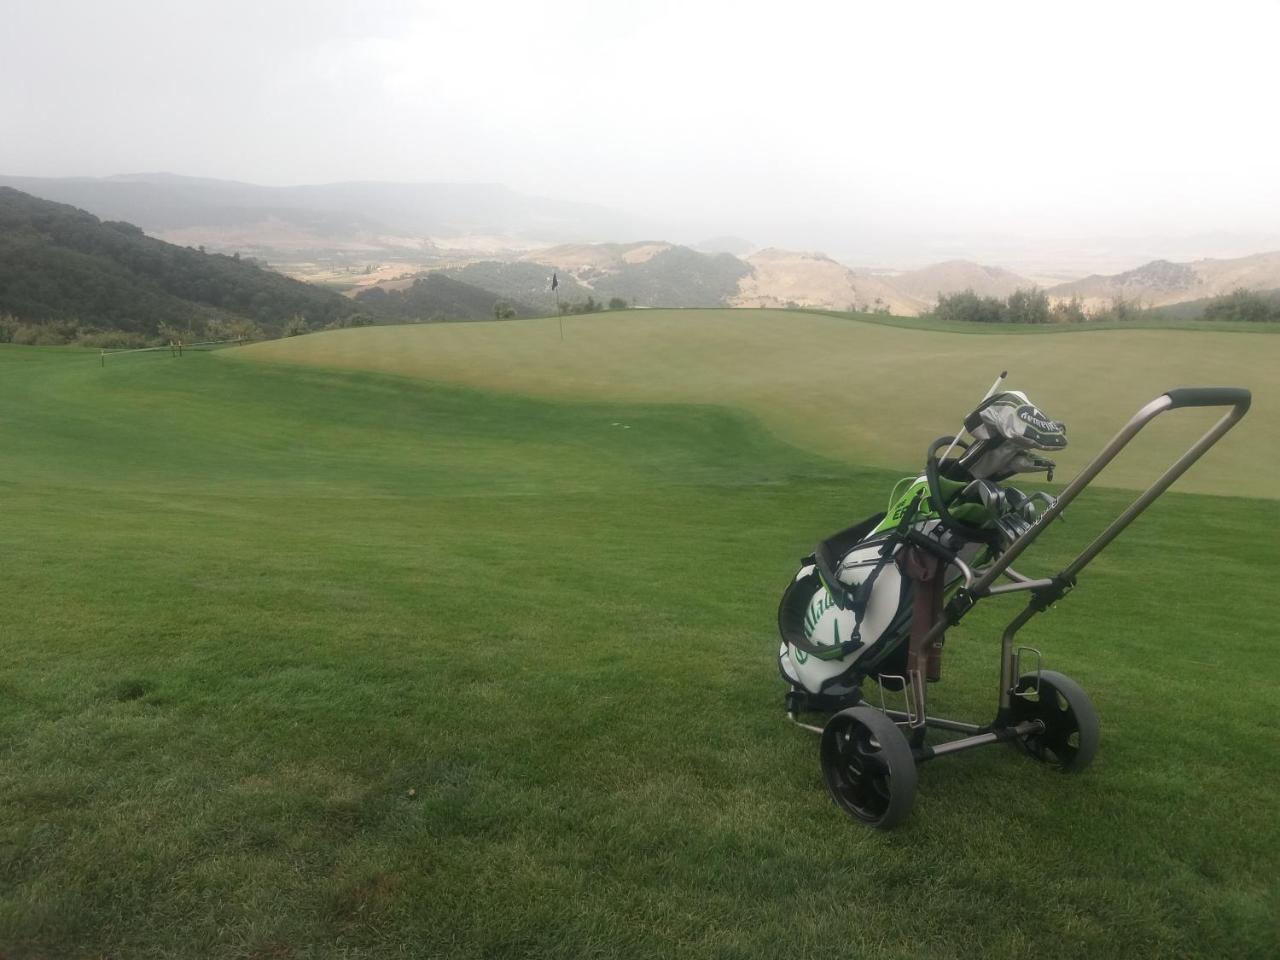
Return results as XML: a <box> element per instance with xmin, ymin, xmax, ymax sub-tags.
<box><xmin>778</xmin><ymin>374</ymin><xmax>1251</xmax><ymax>829</ymax></box>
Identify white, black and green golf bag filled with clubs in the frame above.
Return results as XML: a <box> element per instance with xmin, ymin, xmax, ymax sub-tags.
<box><xmin>778</xmin><ymin>390</ymin><xmax>1066</xmax><ymax>713</ymax></box>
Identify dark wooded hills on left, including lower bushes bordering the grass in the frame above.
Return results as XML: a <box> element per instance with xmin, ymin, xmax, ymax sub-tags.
<box><xmin>0</xmin><ymin>187</ymin><xmax>534</xmax><ymax>346</ymax></box>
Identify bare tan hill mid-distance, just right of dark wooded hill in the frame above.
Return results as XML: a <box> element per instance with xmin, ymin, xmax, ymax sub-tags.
<box><xmin>728</xmin><ymin>248</ymin><xmax>929</xmax><ymax>316</ymax></box>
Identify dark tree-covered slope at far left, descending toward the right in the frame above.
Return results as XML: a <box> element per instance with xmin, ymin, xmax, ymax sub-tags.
<box><xmin>0</xmin><ymin>187</ymin><xmax>357</xmax><ymax>337</ymax></box>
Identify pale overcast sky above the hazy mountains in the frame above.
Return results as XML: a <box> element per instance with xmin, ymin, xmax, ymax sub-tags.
<box><xmin>0</xmin><ymin>0</ymin><xmax>1280</xmax><ymax>256</ymax></box>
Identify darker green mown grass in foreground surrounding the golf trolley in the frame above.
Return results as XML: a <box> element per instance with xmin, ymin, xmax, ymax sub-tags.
<box><xmin>0</xmin><ymin>343</ymin><xmax>1280</xmax><ymax>960</ymax></box>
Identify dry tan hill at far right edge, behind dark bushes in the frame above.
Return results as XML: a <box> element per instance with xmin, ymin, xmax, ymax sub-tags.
<box><xmin>1048</xmin><ymin>252</ymin><xmax>1280</xmax><ymax>307</ymax></box>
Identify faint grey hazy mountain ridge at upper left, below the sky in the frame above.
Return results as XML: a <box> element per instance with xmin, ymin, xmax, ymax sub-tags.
<box><xmin>0</xmin><ymin>174</ymin><xmax>637</xmax><ymax>255</ymax></box>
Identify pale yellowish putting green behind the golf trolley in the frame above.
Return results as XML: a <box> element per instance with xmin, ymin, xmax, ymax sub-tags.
<box><xmin>240</xmin><ymin>310</ymin><xmax>1280</xmax><ymax>497</ymax></box>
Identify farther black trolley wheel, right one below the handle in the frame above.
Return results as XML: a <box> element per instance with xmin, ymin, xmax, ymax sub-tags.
<box><xmin>1011</xmin><ymin>669</ymin><xmax>1100</xmax><ymax>773</ymax></box>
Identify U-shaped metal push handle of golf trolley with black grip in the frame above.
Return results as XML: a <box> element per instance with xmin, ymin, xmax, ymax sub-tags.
<box><xmin>970</xmin><ymin>387</ymin><xmax>1253</xmax><ymax>596</ymax></box>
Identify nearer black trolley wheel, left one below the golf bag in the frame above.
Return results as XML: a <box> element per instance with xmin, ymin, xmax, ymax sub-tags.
<box><xmin>819</xmin><ymin>707</ymin><xmax>915</xmax><ymax>829</ymax></box>
